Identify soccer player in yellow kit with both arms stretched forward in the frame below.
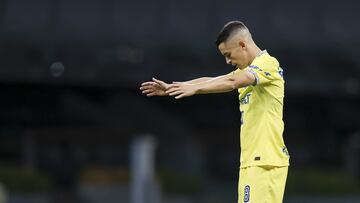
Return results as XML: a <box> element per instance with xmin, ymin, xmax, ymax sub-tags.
<box><xmin>140</xmin><ymin>21</ymin><xmax>289</xmax><ymax>203</ymax></box>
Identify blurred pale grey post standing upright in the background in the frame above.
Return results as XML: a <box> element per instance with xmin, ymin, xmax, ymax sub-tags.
<box><xmin>130</xmin><ymin>136</ymin><xmax>161</xmax><ymax>203</ymax></box>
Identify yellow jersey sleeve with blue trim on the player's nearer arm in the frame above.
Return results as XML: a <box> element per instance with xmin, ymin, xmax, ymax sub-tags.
<box><xmin>247</xmin><ymin>58</ymin><xmax>282</xmax><ymax>85</ymax></box>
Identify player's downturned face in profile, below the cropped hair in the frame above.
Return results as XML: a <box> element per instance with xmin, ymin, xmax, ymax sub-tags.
<box><xmin>218</xmin><ymin>41</ymin><xmax>248</xmax><ymax>69</ymax></box>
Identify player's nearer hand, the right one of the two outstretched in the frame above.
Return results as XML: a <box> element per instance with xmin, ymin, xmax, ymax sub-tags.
<box><xmin>166</xmin><ymin>82</ymin><xmax>196</xmax><ymax>99</ymax></box>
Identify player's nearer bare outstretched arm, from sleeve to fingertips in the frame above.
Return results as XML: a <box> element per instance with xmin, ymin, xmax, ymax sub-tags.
<box><xmin>165</xmin><ymin>71</ymin><xmax>256</xmax><ymax>99</ymax></box>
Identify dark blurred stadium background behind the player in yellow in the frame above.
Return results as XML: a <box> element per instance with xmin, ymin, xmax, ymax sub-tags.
<box><xmin>0</xmin><ymin>0</ymin><xmax>360</xmax><ymax>203</ymax></box>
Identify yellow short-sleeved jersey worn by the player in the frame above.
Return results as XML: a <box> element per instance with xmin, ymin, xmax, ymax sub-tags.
<box><xmin>232</xmin><ymin>50</ymin><xmax>289</xmax><ymax>168</ymax></box>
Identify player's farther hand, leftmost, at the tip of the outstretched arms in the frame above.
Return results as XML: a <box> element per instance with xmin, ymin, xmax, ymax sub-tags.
<box><xmin>140</xmin><ymin>78</ymin><xmax>169</xmax><ymax>97</ymax></box>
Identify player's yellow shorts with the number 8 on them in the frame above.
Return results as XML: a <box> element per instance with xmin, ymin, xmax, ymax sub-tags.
<box><xmin>238</xmin><ymin>166</ymin><xmax>288</xmax><ymax>203</ymax></box>
